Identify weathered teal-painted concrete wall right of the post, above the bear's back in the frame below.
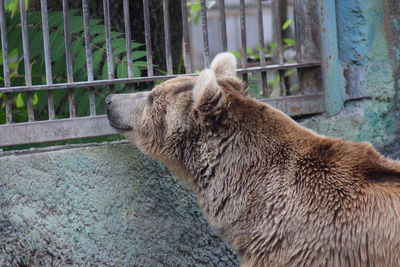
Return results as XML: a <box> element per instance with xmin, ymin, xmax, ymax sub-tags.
<box><xmin>302</xmin><ymin>0</ymin><xmax>400</xmax><ymax>156</ymax></box>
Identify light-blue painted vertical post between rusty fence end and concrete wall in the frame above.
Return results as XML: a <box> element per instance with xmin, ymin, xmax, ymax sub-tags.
<box><xmin>320</xmin><ymin>0</ymin><xmax>345</xmax><ymax>115</ymax></box>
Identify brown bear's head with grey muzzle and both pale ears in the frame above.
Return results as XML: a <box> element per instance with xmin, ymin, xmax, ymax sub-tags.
<box><xmin>106</xmin><ymin>53</ymin><xmax>265</xmax><ymax>191</ymax></box>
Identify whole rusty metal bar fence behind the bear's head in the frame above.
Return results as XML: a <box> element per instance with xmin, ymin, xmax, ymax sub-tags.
<box><xmin>0</xmin><ymin>0</ymin><xmax>324</xmax><ymax>146</ymax></box>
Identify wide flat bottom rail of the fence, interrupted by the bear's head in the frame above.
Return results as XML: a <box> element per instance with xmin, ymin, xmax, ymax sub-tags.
<box><xmin>0</xmin><ymin>94</ymin><xmax>324</xmax><ymax>147</ymax></box>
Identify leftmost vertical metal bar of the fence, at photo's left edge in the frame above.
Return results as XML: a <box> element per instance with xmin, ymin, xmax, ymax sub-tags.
<box><xmin>0</xmin><ymin>0</ymin><xmax>12</xmax><ymax>123</ymax></box>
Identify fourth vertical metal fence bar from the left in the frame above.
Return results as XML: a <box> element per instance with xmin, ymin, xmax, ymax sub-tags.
<box><xmin>62</xmin><ymin>0</ymin><xmax>76</xmax><ymax>118</ymax></box>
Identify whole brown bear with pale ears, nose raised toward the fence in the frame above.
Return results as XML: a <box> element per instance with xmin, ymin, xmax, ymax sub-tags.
<box><xmin>106</xmin><ymin>53</ymin><xmax>400</xmax><ymax>266</ymax></box>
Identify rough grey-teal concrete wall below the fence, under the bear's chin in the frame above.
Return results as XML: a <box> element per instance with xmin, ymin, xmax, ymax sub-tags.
<box><xmin>0</xmin><ymin>144</ymin><xmax>238</xmax><ymax>266</ymax></box>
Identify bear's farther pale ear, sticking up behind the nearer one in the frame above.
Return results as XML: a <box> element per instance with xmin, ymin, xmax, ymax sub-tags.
<box><xmin>210</xmin><ymin>52</ymin><xmax>237</xmax><ymax>78</ymax></box>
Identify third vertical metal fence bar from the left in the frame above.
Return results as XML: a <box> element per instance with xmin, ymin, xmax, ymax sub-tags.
<box><xmin>40</xmin><ymin>0</ymin><xmax>56</xmax><ymax>120</ymax></box>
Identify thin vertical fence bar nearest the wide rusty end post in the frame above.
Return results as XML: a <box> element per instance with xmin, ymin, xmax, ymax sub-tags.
<box><xmin>272</xmin><ymin>0</ymin><xmax>286</xmax><ymax>96</ymax></box>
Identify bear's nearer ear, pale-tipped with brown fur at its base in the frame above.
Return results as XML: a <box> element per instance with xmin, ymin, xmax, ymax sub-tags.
<box><xmin>193</xmin><ymin>69</ymin><xmax>222</xmax><ymax>113</ymax></box>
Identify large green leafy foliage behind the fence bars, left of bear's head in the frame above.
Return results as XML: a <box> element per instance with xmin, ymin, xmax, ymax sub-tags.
<box><xmin>0</xmin><ymin>5</ymin><xmax>147</xmax><ymax>123</ymax></box>
